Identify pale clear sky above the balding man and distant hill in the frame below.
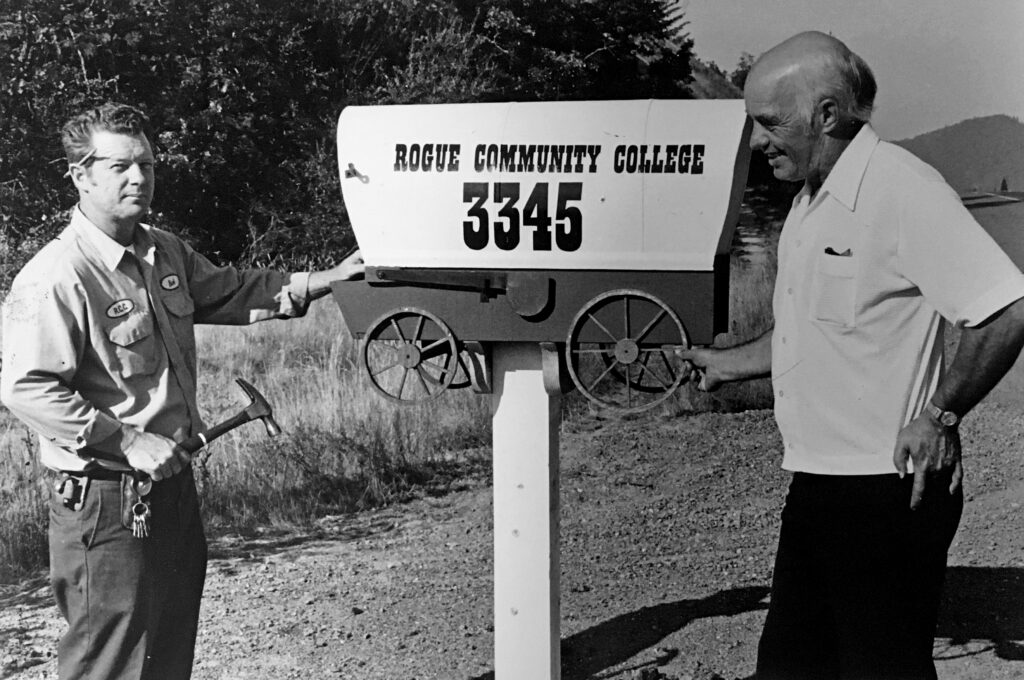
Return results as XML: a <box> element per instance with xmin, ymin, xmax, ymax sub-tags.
<box><xmin>677</xmin><ymin>0</ymin><xmax>1024</xmax><ymax>139</ymax></box>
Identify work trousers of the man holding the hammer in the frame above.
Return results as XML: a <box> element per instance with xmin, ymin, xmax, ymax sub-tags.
<box><xmin>49</xmin><ymin>470</ymin><xmax>207</xmax><ymax>680</ymax></box>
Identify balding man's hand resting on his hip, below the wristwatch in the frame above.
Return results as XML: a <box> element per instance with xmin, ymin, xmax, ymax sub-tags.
<box><xmin>893</xmin><ymin>414</ymin><xmax>964</xmax><ymax>509</ymax></box>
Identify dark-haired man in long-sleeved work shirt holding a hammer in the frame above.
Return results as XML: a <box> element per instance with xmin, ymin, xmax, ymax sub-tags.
<box><xmin>0</xmin><ymin>103</ymin><xmax>362</xmax><ymax>680</ymax></box>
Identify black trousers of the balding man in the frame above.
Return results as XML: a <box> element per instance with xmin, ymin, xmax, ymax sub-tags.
<box><xmin>756</xmin><ymin>473</ymin><xmax>964</xmax><ymax>680</ymax></box>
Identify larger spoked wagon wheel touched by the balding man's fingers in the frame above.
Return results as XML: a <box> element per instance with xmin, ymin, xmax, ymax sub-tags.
<box><xmin>565</xmin><ymin>290</ymin><xmax>689</xmax><ymax>413</ymax></box>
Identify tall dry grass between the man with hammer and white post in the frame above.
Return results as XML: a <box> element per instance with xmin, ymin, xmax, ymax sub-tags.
<box><xmin>196</xmin><ymin>300</ymin><xmax>490</xmax><ymax>528</ymax></box>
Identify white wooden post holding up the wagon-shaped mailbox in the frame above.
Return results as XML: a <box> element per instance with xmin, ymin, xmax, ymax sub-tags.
<box><xmin>492</xmin><ymin>342</ymin><xmax>561</xmax><ymax>680</ymax></box>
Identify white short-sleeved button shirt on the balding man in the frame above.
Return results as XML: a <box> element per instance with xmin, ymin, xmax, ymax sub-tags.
<box><xmin>772</xmin><ymin>125</ymin><xmax>1024</xmax><ymax>474</ymax></box>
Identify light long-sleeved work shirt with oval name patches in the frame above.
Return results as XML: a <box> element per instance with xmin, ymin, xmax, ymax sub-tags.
<box><xmin>0</xmin><ymin>209</ymin><xmax>309</xmax><ymax>471</ymax></box>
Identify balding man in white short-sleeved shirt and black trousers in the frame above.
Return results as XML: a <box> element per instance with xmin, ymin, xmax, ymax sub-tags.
<box><xmin>684</xmin><ymin>33</ymin><xmax>1024</xmax><ymax>680</ymax></box>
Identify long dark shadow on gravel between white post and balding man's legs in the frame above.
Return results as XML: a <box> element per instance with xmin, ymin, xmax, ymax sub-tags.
<box><xmin>473</xmin><ymin>586</ymin><xmax>769</xmax><ymax>680</ymax></box>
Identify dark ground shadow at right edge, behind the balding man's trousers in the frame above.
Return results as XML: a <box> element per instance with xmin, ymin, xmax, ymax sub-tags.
<box><xmin>936</xmin><ymin>566</ymin><xmax>1024</xmax><ymax>662</ymax></box>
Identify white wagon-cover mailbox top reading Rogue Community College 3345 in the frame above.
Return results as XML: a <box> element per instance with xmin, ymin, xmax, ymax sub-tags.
<box><xmin>338</xmin><ymin>100</ymin><xmax>746</xmax><ymax>271</ymax></box>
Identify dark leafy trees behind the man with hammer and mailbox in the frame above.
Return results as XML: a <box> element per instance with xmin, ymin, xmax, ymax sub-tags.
<box><xmin>0</xmin><ymin>0</ymin><xmax>692</xmax><ymax>289</ymax></box>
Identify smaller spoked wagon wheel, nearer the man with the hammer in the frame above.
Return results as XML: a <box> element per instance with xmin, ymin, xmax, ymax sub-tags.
<box><xmin>361</xmin><ymin>307</ymin><xmax>459</xmax><ymax>401</ymax></box>
